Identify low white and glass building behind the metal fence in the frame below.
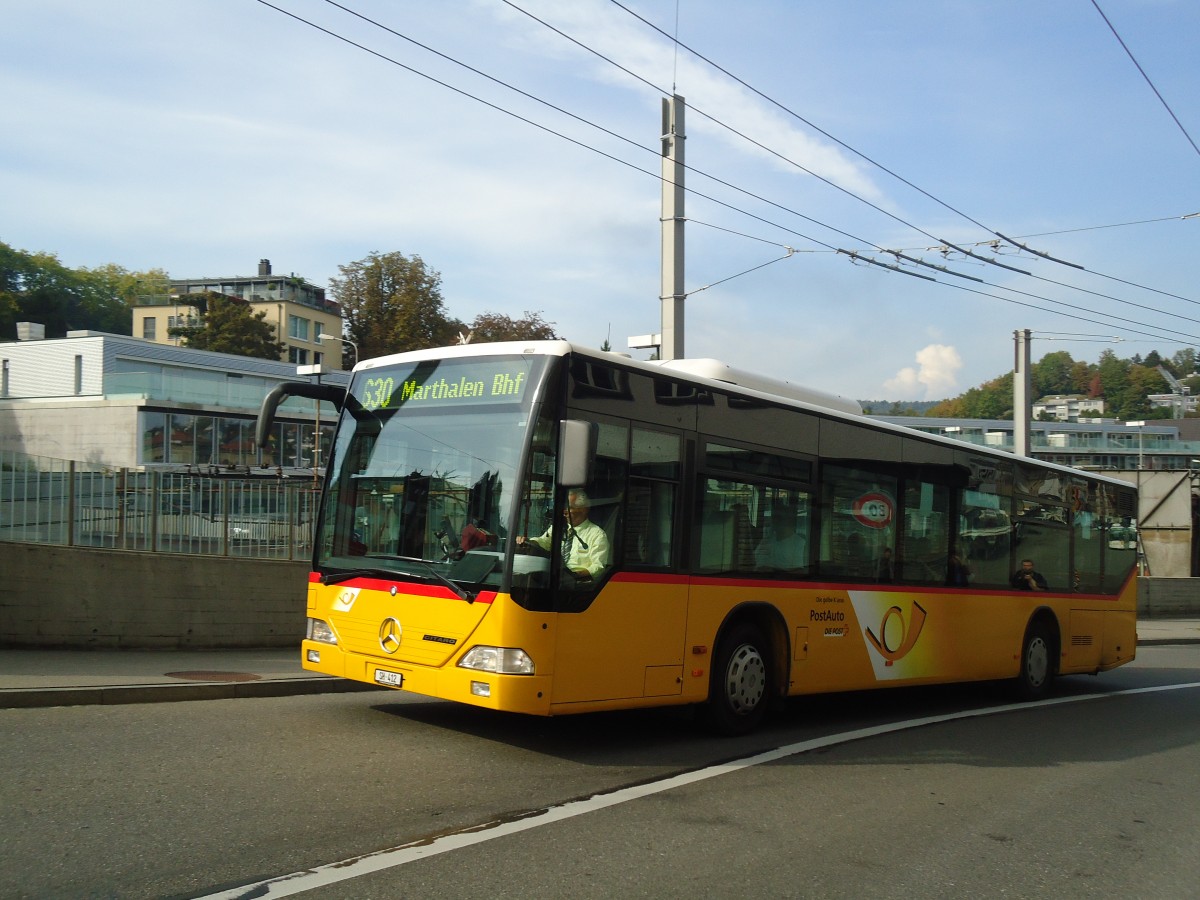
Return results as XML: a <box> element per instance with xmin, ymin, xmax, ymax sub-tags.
<box><xmin>0</xmin><ymin>330</ymin><xmax>349</xmax><ymax>472</ymax></box>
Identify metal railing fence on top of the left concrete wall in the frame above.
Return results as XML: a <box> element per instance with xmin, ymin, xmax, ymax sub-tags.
<box><xmin>0</xmin><ymin>451</ymin><xmax>320</xmax><ymax>559</ymax></box>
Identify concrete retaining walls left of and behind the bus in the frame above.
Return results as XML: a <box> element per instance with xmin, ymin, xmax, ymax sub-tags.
<box><xmin>0</xmin><ymin>541</ymin><xmax>1200</xmax><ymax>649</ymax></box>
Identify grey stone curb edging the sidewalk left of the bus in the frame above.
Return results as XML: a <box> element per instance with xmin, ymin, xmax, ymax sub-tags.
<box><xmin>0</xmin><ymin>676</ymin><xmax>386</xmax><ymax>709</ymax></box>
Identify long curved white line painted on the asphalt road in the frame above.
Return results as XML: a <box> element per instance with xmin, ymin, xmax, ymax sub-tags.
<box><xmin>202</xmin><ymin>682</ymin><xmax>1200</xmax><ymax>900</ymax></box>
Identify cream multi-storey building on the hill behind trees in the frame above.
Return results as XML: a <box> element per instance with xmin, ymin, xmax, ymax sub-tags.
<box><xmin>133</xmin><ymin>259</ymin><xmax>355</xmax><ymax>368</ymax></box>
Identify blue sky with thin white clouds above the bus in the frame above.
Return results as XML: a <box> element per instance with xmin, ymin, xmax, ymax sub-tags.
<box><xmin>0</xmin><ymin>0</ymin><xmax>1200</xmax><ymax>401</ymax></box>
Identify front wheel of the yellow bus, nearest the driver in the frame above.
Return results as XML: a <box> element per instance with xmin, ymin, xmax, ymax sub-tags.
<box><xmin>706</xmin><ymin>622</ymin><xmax>772</xmax><ymax>734</ymax></box>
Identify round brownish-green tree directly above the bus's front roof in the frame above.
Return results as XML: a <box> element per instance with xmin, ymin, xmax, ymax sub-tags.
<box><xmin>329</xmin><ymin>252</ymin><xmax>467</xmax><ymax>359</ymax></box>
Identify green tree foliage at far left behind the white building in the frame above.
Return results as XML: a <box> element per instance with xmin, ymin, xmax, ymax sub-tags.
<box><xmin>0</xmin><ymin>242</ymin><xmax>167</xmax><ymax>340</ymax></box>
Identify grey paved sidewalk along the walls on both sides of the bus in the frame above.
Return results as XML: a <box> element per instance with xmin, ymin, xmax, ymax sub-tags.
<box><xmin>0</xmin><ymin>619</ymin><xmax>1200</xmax><ymax>709</ymax></box>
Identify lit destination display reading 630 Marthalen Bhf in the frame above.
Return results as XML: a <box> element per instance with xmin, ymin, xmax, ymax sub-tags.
<box><xmin>354</xmin><ymin>356</ymin><xmax>530</xmax><ymax>409</ymax></box>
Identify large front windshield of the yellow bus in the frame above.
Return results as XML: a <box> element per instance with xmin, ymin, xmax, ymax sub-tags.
<box><xmin>316</xmin><ymin>355</ymin><xmax>546</xmax><ymax>596</ymax></box>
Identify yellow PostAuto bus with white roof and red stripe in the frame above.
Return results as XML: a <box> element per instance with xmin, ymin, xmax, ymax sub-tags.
<box><xmin>259</xmin><ymin>341</ymin><xmax>1136</xmax><ymax>733</ymax></box>
